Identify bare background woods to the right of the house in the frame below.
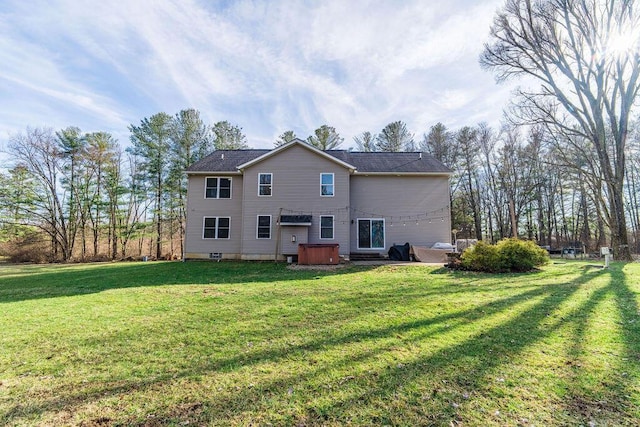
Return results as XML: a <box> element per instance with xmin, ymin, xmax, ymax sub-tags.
<box><xmin>421</xmin><ymin>123</ymin><xmax>640</xmax><ymax>253</ymax></box>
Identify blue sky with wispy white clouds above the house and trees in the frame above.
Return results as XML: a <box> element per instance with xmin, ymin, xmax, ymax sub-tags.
<box><xmin>0</xmin><ymin>0</ymin><xmax>511</xmax><ymax>152</ymax></box>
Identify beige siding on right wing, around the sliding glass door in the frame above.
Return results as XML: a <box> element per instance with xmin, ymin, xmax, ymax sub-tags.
<box><xmin>350</xmin><ymin>175</ymin><xmax>451</xmax><ymax>253</ymax></box>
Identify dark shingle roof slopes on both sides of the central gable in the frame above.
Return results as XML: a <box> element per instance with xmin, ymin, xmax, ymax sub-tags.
<box><xmin>187</xmin><ymin>150</ymin><xmax>452</xmax><ymax>173</ymax></box>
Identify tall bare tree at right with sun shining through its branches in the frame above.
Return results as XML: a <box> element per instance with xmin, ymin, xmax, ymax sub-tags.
<box><xmin>480</xmin><ymin>0</ymin><xmax>640</xmax><ymax>259</ymax></box>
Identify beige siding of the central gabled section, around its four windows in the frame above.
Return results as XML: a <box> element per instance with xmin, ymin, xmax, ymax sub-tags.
<box><xmin>240</xmin><ymin>145</ymin><xmax>350</xmax><ymax>258</ymax></box>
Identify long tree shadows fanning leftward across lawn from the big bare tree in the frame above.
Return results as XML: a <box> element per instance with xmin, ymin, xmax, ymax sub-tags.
<box><xmin>6</xmin><ymin>264</ymin><xmax>591</xmax><ymax>424</ymax></box>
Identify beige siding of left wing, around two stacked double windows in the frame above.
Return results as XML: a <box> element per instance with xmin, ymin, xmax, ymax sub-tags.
<box><xmin>185</xmin><ymin>174</ymin><xmax>242</xmax><ymax>258</ymax></box>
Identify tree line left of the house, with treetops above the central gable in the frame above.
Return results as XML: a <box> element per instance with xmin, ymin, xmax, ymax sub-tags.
<box><xmin>0</xmin><ymin>113</ymin><xmax>420</xmax><ymax>261</ymax></box>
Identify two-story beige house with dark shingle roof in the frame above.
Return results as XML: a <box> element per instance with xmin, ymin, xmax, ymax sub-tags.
<box><xmin>184</xmin><ymin>140</ymin><xmax>451</xmax><ymax>260</ymax></box>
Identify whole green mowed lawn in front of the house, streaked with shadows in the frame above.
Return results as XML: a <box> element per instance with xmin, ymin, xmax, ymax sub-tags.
<box><xmin>0</xmin><ymin>262</ymin><xmax>640</xmax><ymax>426</ymax></box>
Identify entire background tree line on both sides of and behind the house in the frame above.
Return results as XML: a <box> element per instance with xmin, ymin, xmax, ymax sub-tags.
<box><xmin>0</xmin><ymin>109</ymin><xmax>640</xmax><ymax>261</ymax></box>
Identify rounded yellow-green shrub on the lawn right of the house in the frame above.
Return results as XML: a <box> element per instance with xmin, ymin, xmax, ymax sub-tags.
<box><xmin>460</xmin><ymin>238</ymin><xmax>549</xmax><ymax>273</ymax></box>
